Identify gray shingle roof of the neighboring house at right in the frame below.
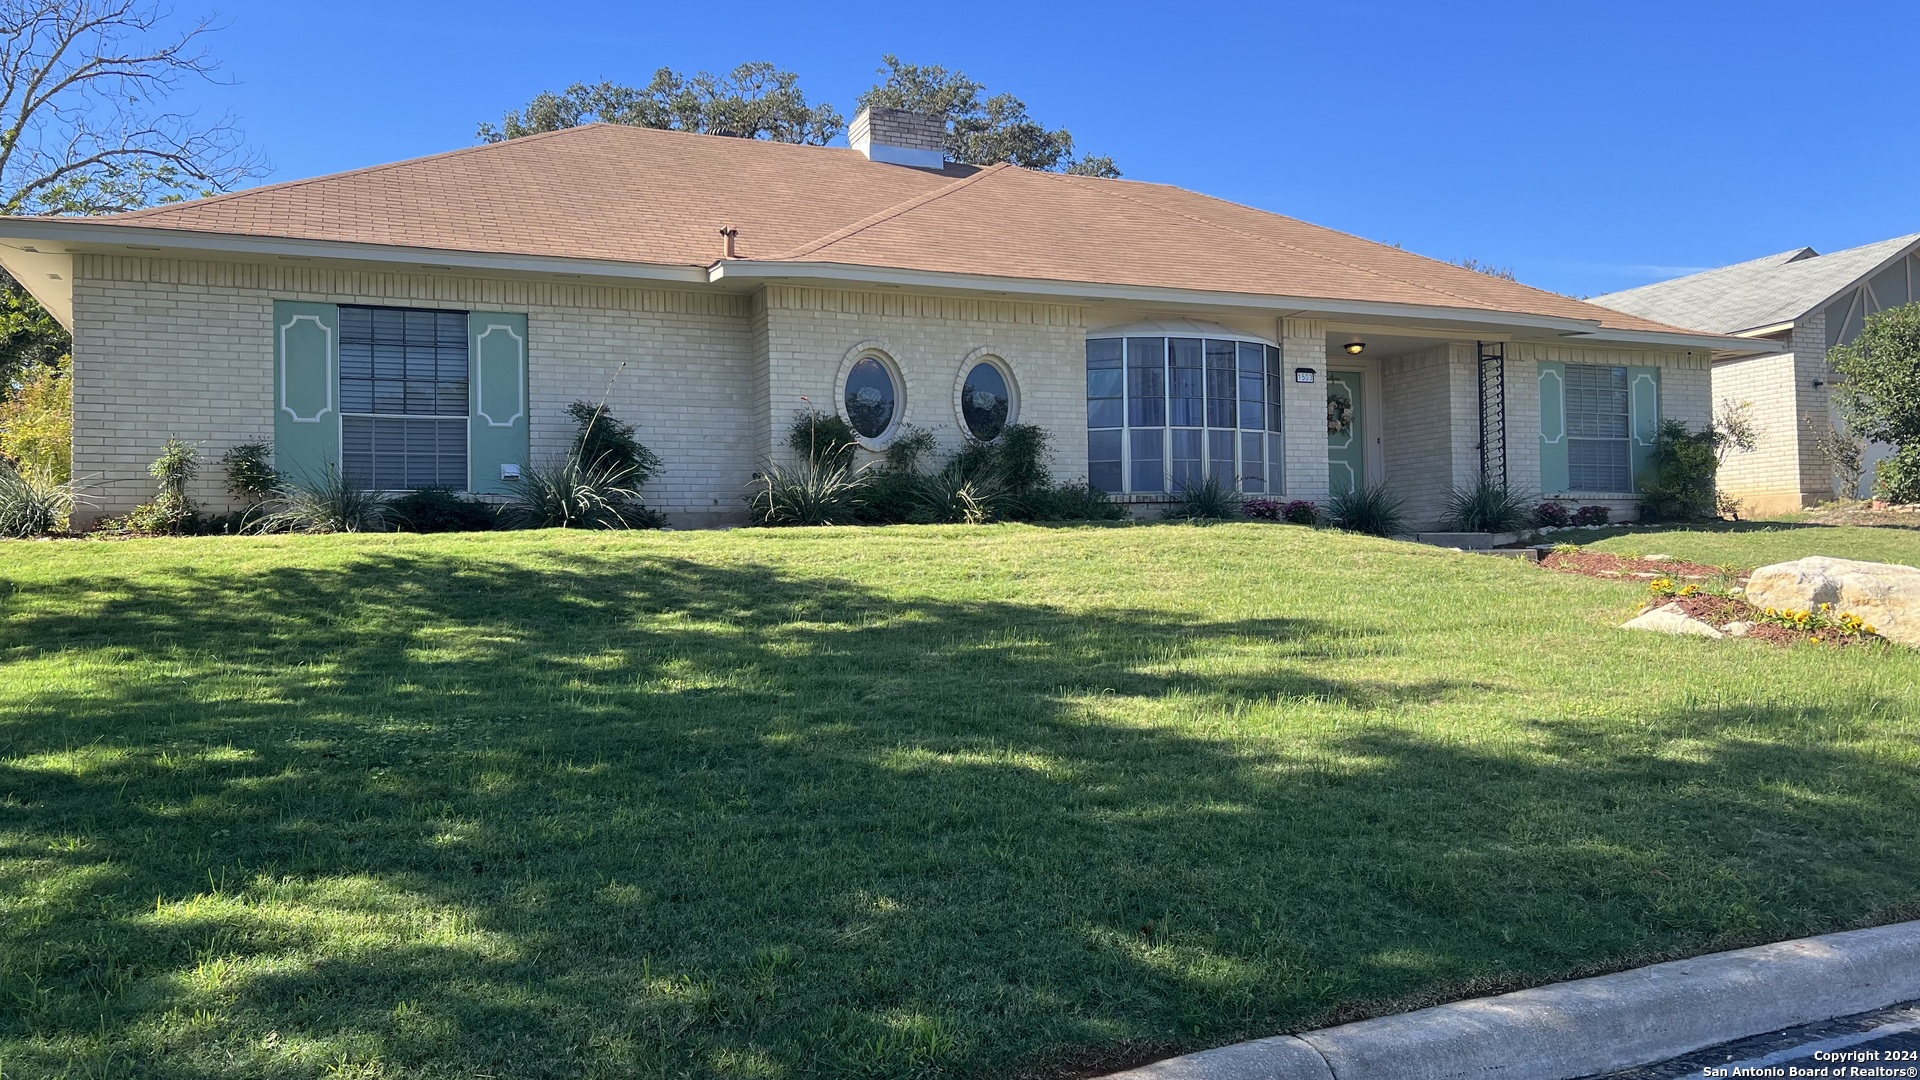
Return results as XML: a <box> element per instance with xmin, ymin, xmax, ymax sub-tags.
<box><xmin>1590</xmin><ymin>233</ymin><xmax>1920</xmax><ymax>334</ymax></box>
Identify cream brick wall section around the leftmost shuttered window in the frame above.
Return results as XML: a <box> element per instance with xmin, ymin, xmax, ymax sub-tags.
<box><xmin>61</xmin><ymin>256</ymin><xmax>756</xmax><ymax>525</ymax></box>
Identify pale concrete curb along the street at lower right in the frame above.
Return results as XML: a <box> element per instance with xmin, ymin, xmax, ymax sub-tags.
<box><xmin>1110</xmin><ymin>920</ymin><xmax>1920</xmax><ymax>1080</ymax></box>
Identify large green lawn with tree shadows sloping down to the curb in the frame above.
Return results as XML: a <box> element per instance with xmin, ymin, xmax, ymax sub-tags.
<box><xmin>0</xmin><ymin>525</ymin><xmax>1920</xmax><ymax>1080</ymax></box>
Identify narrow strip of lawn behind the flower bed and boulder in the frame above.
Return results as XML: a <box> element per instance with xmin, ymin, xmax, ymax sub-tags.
<box><xmin>1553</xmin><ymin>521</ymin><xmax>1920</xmax><ymax>571</ymax></box>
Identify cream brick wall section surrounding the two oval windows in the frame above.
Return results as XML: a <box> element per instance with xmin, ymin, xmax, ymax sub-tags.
<box><xmin>751</xmin><ymin>284</ymin><xmax>1087</xmax><ymax>480</ymax></box>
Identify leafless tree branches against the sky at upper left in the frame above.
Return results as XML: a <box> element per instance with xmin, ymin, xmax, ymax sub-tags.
<box><xmin>0</xmin><ymin>0</ymin><xmax>263</xmax><ymax>213</ymax></box>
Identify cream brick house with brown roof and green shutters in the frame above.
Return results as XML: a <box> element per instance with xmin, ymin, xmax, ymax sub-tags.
<box><xmin>0</xmin><ymin>110</ymin><xmax>1751</xmax><ymax>525</ymax></box>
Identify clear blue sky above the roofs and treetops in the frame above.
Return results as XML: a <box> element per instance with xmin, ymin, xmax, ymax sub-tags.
<box><xmin>161</xmin><ymin>0</ymin><xmax>1920</xmax><ymax>294</ymax></box>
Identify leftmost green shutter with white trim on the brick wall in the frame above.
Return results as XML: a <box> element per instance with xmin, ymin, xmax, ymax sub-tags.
<box><xmin>273</xmin><ymin>300</ymin><xmax>340</xmax><ymax>480</ymax></box>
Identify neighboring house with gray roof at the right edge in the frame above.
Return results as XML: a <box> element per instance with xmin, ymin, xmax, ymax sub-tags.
<box><xmin>1594</xmin><ymin>234</ymin><xmax>1920</xmax><ymax>513</ymax></box>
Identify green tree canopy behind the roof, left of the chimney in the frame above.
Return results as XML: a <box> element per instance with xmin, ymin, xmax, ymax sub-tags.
<box><xmin>478</xmin><ymin>61</ymin><xmax>847</xmax><ymax>146</ymax></box>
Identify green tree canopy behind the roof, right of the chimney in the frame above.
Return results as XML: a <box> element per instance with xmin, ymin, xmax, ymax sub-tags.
<box><xmin>860</xmin><ymin>54</ymin><xmax>1119</xmax><ymax>177</ymax></box>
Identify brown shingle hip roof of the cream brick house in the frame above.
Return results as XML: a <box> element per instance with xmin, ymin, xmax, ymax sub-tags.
<box><xmin>100</xmin><ymin>125</ymin><xmax>1670</xmax><ymax>331</ymax></box>
